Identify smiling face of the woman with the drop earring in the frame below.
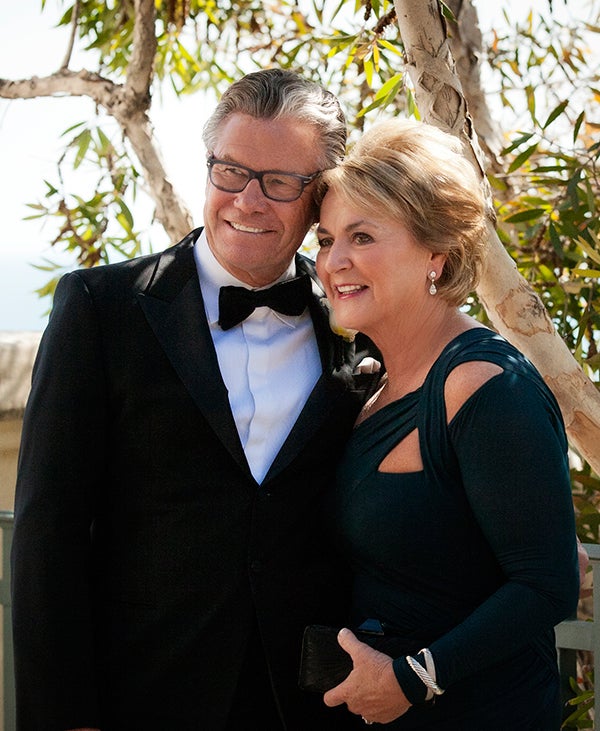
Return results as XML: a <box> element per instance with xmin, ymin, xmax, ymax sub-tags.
<box><xmin>317</xmin><ymin>190</ymin><xmax>443</xmax><ymax>337</ymax></box>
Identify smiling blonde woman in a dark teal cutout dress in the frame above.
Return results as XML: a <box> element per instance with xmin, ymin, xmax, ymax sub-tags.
<box><xmin>317</xmin><ymin>120</ymin><xmax>579</xmax><ymax>731</ymax></box>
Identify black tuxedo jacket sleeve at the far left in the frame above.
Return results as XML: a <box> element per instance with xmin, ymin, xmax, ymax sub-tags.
<box><xmin>11</xmin><ymin>273</ymin><xmax>107</xmax><ymax>731</ymax></box>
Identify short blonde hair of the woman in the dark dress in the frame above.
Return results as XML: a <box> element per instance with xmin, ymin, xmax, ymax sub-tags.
<box><xmin>320</xmin><ymin>119</ymin><xmax>486</xmax><ymax>306</ymax></box>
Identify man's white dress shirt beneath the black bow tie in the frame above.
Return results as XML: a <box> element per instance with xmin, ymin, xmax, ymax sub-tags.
<box><xmin>194</xmin><ymin>232</ymin><xmax>322</xmax><ymax>484</ymax></box>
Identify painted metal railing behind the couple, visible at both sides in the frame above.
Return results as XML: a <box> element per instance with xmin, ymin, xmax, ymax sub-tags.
<box><xmin>0</xmin><ymin>510</ymin><xmax>600</xmax><ymax>731</ymax></box>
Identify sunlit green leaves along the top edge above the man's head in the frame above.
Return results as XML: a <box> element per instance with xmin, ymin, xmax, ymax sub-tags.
<box><xmin>55</xmin><ymin>0</ymin><xmax>402</xmax><ymax>116</ymax></box>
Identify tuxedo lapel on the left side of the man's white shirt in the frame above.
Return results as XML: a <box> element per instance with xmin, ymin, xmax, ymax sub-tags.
<box><xmin>138</xmin><ymin>231</ymin><xmax>249</xmax><ymax>473</ymax></box>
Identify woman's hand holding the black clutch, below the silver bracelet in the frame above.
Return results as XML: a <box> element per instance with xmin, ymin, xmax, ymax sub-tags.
<box><xmin>323</xmin><ymin>629</ymin><xmax>411</xmax><ymax>723</ymax></box>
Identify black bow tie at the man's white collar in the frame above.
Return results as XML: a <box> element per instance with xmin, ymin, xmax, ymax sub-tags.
<box><xmin>219</xmin><ymin>274</ymin><xmax>312</xmax><ymax>330</ymax></box>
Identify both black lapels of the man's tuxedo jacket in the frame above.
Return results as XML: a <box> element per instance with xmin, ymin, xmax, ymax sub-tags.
<box><xmin>137</xmin><ymin>237</ymin><xmax>354</xmax><ymax>482</ymax></box>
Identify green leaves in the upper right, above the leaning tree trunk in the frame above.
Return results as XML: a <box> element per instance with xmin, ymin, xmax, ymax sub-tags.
<box><xmin>490</xmin><ymin>4</ymin><xmax>600</xmax><ymax>382</ymax></box>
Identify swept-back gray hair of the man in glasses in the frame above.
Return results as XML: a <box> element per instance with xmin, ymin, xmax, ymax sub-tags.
<box><xmin>202</xmin><ymin>69</ymin><xmax>346</xmax><ymax>170</ymax></box>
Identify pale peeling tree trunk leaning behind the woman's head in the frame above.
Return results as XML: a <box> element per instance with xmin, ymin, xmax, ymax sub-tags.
<box><xmin>394</xmin><ymin>0</ymin><xmax>600</xmax><ymax>474</ymax></box>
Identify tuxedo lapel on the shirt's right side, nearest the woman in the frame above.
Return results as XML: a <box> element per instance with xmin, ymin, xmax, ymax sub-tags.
<box><xmin>265</xmin><ymin>257</ymin><xmax>354</xmax><ymax>482</ymax></box>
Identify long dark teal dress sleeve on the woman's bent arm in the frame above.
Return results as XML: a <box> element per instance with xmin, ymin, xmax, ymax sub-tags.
<box><xmin>430</xmin><ymin>372</ymin><xmax>579</xmax><ymax>687</ymax></box>
